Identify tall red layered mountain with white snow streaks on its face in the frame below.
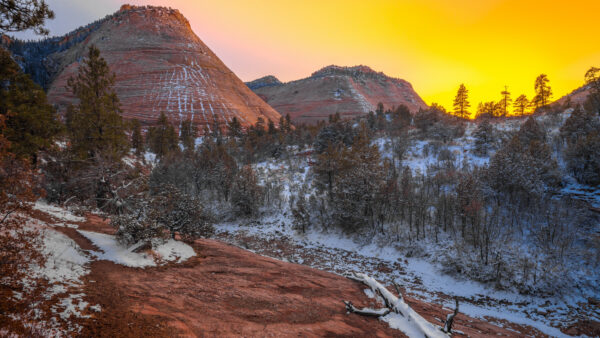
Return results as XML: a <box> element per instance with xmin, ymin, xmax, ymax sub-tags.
<box><xmin>2</xmin><ymin>5</ymin><xmax>280</xmax><ymax>129</ymax></box>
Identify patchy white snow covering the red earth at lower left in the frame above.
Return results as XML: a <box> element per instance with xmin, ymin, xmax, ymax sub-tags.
<box><xmin>14</xmin><ymin>200</ymin><xmax>195</xmax><ymax>336</ymax></box>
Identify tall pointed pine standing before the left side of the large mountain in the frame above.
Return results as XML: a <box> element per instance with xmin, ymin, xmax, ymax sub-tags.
<box><xmin>67</xmin><ymin>46</ymin><xmax>128</xmax><ymax>160</ymax></box>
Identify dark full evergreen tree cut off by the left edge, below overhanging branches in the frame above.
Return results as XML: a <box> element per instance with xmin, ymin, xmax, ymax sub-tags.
<box><xmin>0</xmin><ymin>48</ymin><xmax>61</xmax><ymax>164</ymax></box>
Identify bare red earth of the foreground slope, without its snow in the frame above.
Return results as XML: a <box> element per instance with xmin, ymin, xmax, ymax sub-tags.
<box><xmin>27</xmin><ymin>211</ymin><xmax>580</xmax><ymax>337</ymax></box>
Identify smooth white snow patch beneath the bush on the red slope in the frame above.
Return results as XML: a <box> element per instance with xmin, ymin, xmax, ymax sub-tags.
<box><xmin>78</xmin><ymin>230</ymin><xmax>196</xmax><ymax>268</ymax></box>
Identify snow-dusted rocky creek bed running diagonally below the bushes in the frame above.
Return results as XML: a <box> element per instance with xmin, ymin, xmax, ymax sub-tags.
<box><xmin>217</xmin><ymin>218</ymin><xmax>580</xmax><ymax>337</ymax></box>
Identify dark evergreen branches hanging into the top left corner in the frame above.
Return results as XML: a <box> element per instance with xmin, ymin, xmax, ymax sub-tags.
<box><xmin>0</xmin><ymin>0</ymin><xmax>54</xmax><ymax>35</ymax></box>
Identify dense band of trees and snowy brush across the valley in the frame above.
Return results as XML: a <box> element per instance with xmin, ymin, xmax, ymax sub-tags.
<box><xmin>0</xmin><ymin>40</ymin><xmax>600</xmax><ymax>293</ymax></box>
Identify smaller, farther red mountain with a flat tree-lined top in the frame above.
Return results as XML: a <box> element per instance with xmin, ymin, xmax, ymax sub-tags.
<box><xmin>246</xmin><ymin>66</ymin><xmax>427</xmax><ymax>123</ymax></box>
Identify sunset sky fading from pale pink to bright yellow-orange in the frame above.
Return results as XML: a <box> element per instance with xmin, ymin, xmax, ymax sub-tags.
<box><xmin>10</xmin><ymin>0</ymin><xmax>600</xmax><ymax>111</ymax></box>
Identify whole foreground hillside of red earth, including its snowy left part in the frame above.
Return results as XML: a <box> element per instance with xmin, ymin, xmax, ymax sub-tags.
<box><xmin>16</xmin><ymin>202</ymin><xmax>568</xmax><ymax>337</ymax></box>
